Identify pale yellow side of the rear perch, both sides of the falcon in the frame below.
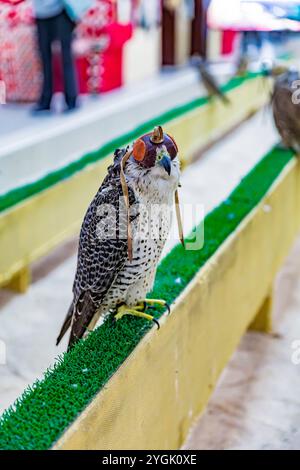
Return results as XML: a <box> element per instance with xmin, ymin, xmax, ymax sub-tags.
<box><xmin>0</xmin><ymin>77</ymin><xmax>268</xmax><ymax>292</ymax></box>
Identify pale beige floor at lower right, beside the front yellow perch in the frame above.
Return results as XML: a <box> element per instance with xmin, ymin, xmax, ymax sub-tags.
<box><xmin>184</xmin><ymin>239</ymin><xmax>300</xmax><ymax>450</ymax></box>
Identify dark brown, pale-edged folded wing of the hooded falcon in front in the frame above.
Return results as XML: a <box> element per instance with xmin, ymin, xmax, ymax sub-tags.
<box><xmin>58</xmin><ymin>150</ymin><xmax>135</xmax><ymax>346</ymax></box>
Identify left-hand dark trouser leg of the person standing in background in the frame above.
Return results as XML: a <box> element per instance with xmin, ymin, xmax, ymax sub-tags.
<box><xmin>37</xmin><ymin>19</ymin><xmax>53</xmax><ymax>109</ymax></box>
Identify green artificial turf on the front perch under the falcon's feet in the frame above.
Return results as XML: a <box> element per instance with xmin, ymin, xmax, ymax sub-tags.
<box><xmin>0</xmin><ymin>148</ymin><xmax>293</xmax><ymax>449</ymax></box>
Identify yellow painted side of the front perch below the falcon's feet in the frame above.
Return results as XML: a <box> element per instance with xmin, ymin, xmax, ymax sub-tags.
<box><xmin>54</xmin><ymin>160</ymin><xmax>300</xmax><ymax>450</ymax></box>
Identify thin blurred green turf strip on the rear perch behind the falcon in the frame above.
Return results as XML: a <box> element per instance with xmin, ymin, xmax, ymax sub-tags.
<box><xmin>0</xmin><ymin>73</ymin><xmax>261</xmax><ymax>213</ymax></box>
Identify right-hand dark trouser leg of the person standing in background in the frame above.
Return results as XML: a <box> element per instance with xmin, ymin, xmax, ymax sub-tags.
<box><xmin>57</xmin><ymin>12</ymin><xmax>77</xmax><ymax>109</ymax></box>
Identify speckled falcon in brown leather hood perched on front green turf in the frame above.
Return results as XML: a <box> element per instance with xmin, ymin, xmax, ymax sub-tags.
<box><xmin>57</xmin><ymin>127</ymin><xmax>182</xmax><ymax>348</ymax></box>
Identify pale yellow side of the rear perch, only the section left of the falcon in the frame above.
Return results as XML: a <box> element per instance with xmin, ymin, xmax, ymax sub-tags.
<box><xmin>0</xmin><ymin>159</ymin><xmax>109</xmax><ymax>286</ymax></box>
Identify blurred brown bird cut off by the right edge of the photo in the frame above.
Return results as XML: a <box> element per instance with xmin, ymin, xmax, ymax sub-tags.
<box><xmin>271</xmin><ymin>67</ymin><xmax>300</xmax><ymax>153</ymax></box>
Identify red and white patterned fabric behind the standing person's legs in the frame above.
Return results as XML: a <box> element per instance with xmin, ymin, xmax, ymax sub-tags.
<box><xmin>0</xmin><ymin>0</ymin><xmax>132</xmax><ymax>101</ymax></box>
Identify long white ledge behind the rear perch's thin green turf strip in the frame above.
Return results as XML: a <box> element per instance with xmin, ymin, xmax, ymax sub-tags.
<box><xmin>0</xmin><ymin>69</ymin><xmax>204</xmax><ymax>194</ymax></box>
